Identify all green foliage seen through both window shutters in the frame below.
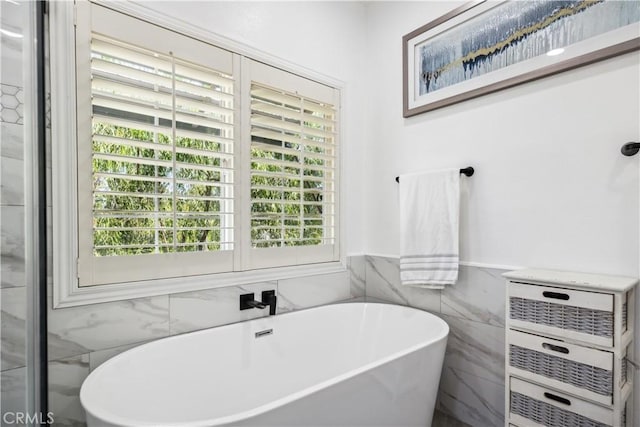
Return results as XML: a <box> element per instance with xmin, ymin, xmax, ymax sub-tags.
<box><xmin>93</xmin><ymin>123</ymin><xmax>332</xmax><ymax>256</ymax></box>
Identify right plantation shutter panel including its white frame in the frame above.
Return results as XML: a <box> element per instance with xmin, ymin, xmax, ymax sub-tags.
<box><xmin>248</xmin><ymin>61</ymin><xmax>339</xmax><ymax>268</ymax></box>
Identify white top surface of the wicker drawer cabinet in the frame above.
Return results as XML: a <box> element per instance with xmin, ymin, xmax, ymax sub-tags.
<box><xmin>503</xmin><ymin>269</ymin><xmax>638</xmax><ymax>292</ymax></box>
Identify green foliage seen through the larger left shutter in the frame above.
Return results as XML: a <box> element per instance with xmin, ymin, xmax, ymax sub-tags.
<box><xmin>93</xmin><ymin>123</ymin><xmax>221</xmax><ymax>256</ymax></box>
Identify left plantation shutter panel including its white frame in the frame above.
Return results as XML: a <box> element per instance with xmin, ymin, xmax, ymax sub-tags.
<box><xmin>78</xmin><ymin>5</ymin><xmax>235</xmax><ymax>286</ymax></box>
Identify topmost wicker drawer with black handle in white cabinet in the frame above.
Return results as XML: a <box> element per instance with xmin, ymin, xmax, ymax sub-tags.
<box><xmin>509</xmin><ymin>282</ymin><xmax>614</xmax><ymax>347</ymax></box>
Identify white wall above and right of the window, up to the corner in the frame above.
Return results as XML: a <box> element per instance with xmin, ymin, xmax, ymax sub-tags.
<box><xmin>131</xmin><ymin>0</ymin><xmax>366</xmax><ymax>254</ymax></box>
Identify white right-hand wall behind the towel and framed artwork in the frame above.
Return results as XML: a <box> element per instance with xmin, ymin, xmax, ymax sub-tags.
<box><xmin>365</xmin><ymin>2</ymin><xmax>640</xmax><ymax>276</ymax></box>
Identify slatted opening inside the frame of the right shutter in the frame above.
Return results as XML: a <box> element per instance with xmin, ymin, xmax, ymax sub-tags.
<box><xmin>251</xmin><ymin>84</ymin><xmax>335</xmax><ymax>248</ymax></box>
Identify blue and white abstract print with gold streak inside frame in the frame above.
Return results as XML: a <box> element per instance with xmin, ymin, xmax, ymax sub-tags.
<box><xmin>416</xmin><ymin>0</ymin><xmax>640</xmax><ymax>96</ymax></box>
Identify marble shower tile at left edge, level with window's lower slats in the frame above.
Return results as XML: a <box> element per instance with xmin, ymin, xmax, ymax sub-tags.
<box><xmin>0</xmin><ymin>206</ymin><xmax>25</xmax><ymax>288</ymax></box>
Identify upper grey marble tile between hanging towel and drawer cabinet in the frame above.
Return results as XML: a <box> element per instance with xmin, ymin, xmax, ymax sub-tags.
<box><xmin>441</xmin><ymin>266</ymin><xmax>506</xmax><ymax>327</ymax></box>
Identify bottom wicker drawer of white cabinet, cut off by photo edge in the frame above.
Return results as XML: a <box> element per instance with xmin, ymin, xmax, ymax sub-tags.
<box><xmin>509</xmin><ymin>377</ymin><xmax>613</xmax><ymax>427</ymax></box>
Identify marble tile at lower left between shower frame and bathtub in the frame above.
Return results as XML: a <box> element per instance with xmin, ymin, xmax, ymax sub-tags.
<box><xmin>49</xmin><ymin>354</ymin><xmax>89</xmax><ymax>427</ymax></box>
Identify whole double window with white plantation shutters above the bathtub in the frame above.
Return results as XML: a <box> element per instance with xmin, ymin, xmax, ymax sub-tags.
<box><xmin>52</xmin><ymin>2</ymin><xmax>340</xmax><ymax>299</ymax></box>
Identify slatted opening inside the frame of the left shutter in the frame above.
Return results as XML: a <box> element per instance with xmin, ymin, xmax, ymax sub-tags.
<box><xmin>91</xmin><ymin>35</ymin><xmax>233</xmax><ymax>256</ymax></box>
